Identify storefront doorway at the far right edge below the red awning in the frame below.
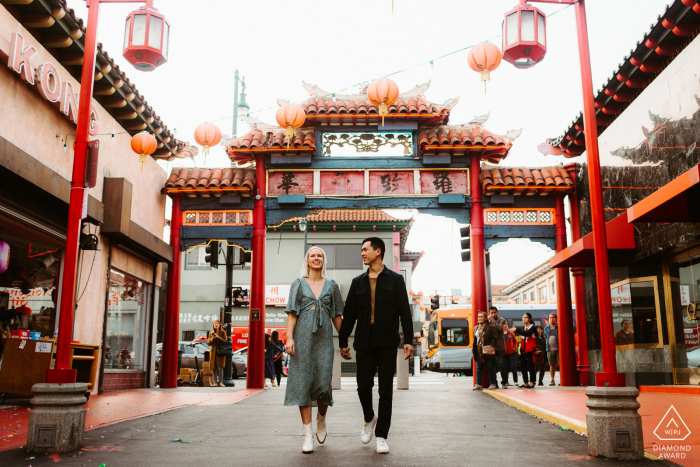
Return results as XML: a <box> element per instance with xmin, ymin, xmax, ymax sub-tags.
<box><xmin>664</xmin><ymin>248</ymin><xmax>700</xmax><ymax>384</ymax></box>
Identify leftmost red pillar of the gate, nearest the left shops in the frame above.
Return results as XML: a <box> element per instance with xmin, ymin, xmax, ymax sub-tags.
<box><xmin>159</xmin><ymin>196</ymin><xmax>182</xmax><ymax>388</ymax></box>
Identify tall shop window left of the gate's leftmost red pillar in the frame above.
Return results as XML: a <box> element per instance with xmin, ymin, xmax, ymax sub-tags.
<box><xmin>105</xmin><ymin>269</ymin><xmax>149</xmax><ymax>370</ymax></box>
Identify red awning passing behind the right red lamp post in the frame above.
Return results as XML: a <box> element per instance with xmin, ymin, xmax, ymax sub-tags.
<box><xmin>550</xmin><ymin>213</ymin><xmax>634</xmax><ymax>268</ymax></box>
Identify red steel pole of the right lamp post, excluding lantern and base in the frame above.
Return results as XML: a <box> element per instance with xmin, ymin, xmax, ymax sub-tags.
<box><xmin>575</xmin><ymin>0</ymin><xmax>626</xmax><ymax>387</ymax></box>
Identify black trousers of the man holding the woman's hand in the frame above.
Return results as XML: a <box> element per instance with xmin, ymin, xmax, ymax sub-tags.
<box><xmin>355</xmin><ymin>347</ymin><xmax>397</xmax><ymax>439</ymax></box>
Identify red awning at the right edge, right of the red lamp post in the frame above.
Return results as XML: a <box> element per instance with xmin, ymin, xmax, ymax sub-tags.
<box><xmin>627</xmin><ymin>165</ymin><xmax>700</xmax><ymax>222</ymax></box>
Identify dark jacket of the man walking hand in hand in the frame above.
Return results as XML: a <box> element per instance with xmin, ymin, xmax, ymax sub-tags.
<box><xmin>338</xmin><ymin>266</ymin><xmax>413</xmax><ymax>350</ymax></box>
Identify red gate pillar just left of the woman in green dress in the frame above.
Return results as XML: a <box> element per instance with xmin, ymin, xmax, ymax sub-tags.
<box><xmin>246</xmin><ymin>156</ymin><xmax>267</xmax><ymax>389</ymax></box>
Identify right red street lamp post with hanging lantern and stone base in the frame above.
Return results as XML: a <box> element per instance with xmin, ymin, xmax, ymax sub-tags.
<box><xmin>503</xmin><ymin>0</ymin><xmax>644</xmax><ymax>459</ymax></box>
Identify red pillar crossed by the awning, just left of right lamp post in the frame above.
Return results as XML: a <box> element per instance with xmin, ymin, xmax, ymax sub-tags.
<box><xmin>564</xmin><ymin>164</ymin><xmax>591</xmax><ymax>386</ymax></box>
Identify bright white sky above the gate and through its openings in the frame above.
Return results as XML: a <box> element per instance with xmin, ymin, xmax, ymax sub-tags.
<box><xmin>68</xmin><ymin>0</ymin><xmax>669</xmax><ymax>295</ymax></box>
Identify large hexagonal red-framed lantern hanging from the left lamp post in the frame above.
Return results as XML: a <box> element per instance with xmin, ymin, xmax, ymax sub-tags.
<box><xmin>123</xmin><ymin>6</ymin><xmax>170</xmax><ymax>71</ymax></box>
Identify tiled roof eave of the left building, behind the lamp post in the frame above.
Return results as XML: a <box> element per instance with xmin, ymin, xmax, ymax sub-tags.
<box><xmin>2</xmin><ymin>0</ymin><xmax>183</xmax><ymax>160</ymax></box>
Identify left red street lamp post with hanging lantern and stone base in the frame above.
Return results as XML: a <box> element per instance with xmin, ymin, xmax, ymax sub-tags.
<box><xmin>27</xmin><ymin>0</ymin><xmax>170</xmax><ymax>453</ymax></box>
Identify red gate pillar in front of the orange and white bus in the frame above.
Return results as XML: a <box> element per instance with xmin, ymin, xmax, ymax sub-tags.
<box><xmin>469</xmin><ymin>156</ymin><xmax>486</xmax><ymax>384</ymax></box>
